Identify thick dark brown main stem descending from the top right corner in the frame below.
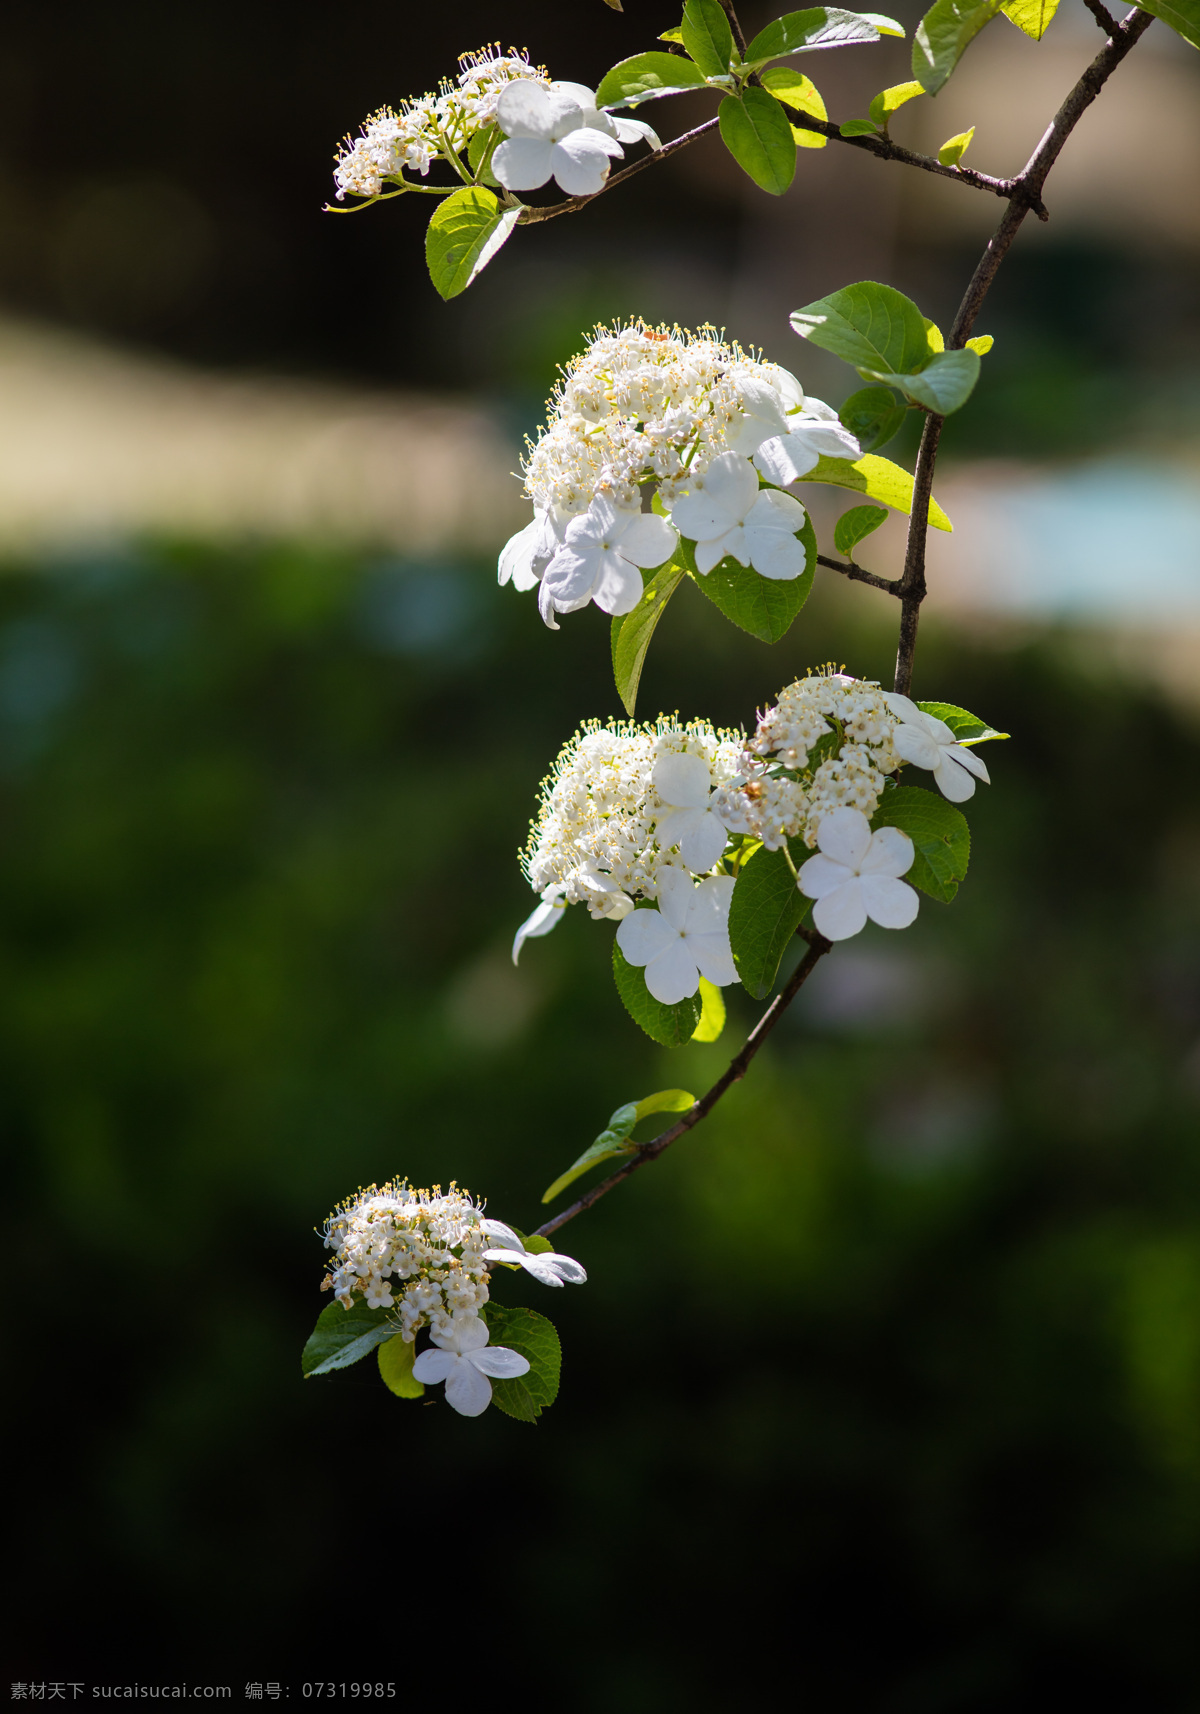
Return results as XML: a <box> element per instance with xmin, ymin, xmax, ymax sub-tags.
<box><xmin>895</xmin><ymin>7</ymin><xmax>1154</xmax><ymax>696</ymax></box>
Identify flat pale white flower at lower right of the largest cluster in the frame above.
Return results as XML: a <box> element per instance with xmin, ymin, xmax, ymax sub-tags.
<box><xmin>670</xmin><ymin>452</ymin><xmax>804</xmax><ymax>579</ymax></box>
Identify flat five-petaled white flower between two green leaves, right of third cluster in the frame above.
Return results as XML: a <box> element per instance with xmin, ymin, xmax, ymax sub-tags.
<box><xmin>797</xmin><ymin>809</ymin><xmax>921</xmax><ymax>941</ymax></box>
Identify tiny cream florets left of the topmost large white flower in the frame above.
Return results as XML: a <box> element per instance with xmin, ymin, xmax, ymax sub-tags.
<box><xmin>333</xmin><ymin>43</ymin><xmax>550</xmax><ymax>202</ymax></box>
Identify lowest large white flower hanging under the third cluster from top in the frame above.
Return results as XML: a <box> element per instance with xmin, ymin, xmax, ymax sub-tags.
<box><xmin>617</xmin><ymin>869</ymin><xmax>737</xmax><ymax>1006</ymax></box>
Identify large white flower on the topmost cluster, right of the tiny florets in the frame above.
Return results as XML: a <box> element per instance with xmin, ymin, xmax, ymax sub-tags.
<box><xmin>492</xmin><ymin>79</ymin><xmax>624</xmax><ymax>197</ymax></box>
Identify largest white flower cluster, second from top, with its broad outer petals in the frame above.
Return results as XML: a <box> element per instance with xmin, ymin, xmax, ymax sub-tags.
<box><xmin>499</xmin><ymin>321</ymin><xmax>861</xmax><ymax>626</ymax></box>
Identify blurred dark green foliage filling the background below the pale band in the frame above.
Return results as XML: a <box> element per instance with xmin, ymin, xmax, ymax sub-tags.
<box><xmin>9</xmin><ymin>547</ymin><xmax>1200</xmax><ymax>1693</ymax></box>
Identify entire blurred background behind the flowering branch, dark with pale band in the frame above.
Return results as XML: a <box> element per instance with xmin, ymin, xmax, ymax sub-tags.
<box><xmin>0</xmin><ymin>0</ymin><xmax>1200</xmax><ymax>1714</ymax></box>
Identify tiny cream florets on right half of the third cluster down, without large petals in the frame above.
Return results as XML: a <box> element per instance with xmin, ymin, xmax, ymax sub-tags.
<box><xmin>715</xmin><ymin>670</ymin><xmax>902</xmax><ymax>850</ymax></box>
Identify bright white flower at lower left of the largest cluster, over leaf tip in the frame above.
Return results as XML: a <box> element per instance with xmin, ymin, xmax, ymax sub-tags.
<box><xmin>538</xmin><ymin>494</ymin><xmax>677</xmax><ymax>631</ymax></box>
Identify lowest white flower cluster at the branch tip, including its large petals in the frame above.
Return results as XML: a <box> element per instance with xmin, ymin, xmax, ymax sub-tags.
<box><xmin>321</xmin><ymin>1179</ymin><xmax>588</xmax><ymax>1416</ymax></box>
